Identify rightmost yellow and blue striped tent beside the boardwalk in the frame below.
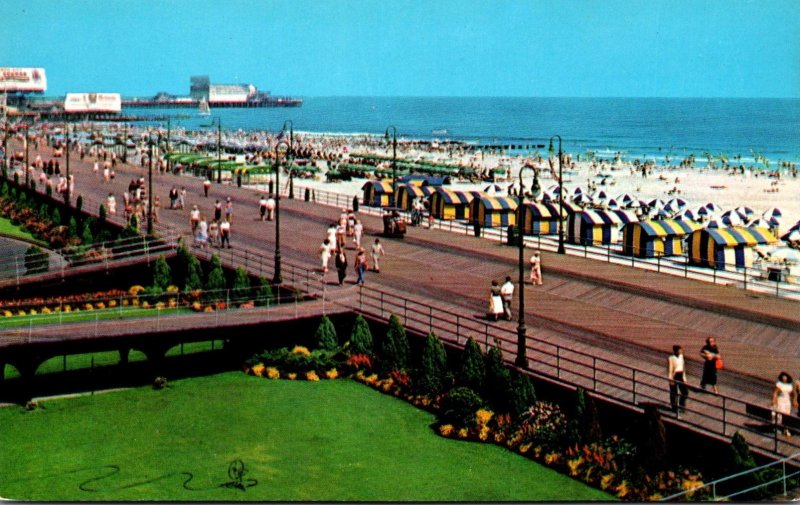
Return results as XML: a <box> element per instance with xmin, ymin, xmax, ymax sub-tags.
<box><xmin>687</xmin><ymin>226</ymin><xmax>778</xmax><ymax>270</ymax></box>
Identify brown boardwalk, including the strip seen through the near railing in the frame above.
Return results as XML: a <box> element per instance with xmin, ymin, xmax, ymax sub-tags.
<box><xmin>4</xmin><ymin>139</ymin><xmax>800</xmax><ymax>451</ymax></box>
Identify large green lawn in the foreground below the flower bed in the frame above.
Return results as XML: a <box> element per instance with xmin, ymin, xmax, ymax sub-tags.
<box><xmin>0</xmin><ymin>372</ymin><xmax>612</xmax><ymax>501</ymax></box>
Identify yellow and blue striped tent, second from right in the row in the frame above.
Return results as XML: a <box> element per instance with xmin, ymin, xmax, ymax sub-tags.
<box><xmin>622</xmin><ymin>219</ymin><xmax>701</xmax><ymax>258</ymax></box>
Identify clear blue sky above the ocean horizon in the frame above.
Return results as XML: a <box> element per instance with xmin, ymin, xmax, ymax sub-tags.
<box><xmin>0</xmin><ymin>0</ymin><xmax>800</xmax><ymax>97</ymax></box>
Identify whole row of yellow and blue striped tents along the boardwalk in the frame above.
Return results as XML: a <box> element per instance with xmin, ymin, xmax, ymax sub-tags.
<box><xmin>363</xmin><ymin>178</ymin><xmax>800</xmax><ymax>269</ymax></box>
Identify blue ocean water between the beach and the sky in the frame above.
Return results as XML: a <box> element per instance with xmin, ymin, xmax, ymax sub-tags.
<box><xmin>125</xmin><ymin>97</ymin><xmax>800</xmax><ymax>163</ymax></box>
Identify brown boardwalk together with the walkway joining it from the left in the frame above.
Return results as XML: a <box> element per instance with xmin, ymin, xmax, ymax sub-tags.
<box><xmin>0</xmin><ymin>138</ymin><xmax>800</xmax><ymax>455</ymax></box>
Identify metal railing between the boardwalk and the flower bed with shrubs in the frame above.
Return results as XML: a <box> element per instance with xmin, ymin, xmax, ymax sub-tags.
<box><xmin>357</xmin><ymin>287</ymin><xmax>800</xmax><ymax>454</ymax></box>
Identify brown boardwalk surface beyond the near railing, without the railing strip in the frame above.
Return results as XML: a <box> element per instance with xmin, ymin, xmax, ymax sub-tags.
<box><xmin>6</xmin><ymin>139</ymin><xmax>800</xmax><ymax>456</ymax></box>
